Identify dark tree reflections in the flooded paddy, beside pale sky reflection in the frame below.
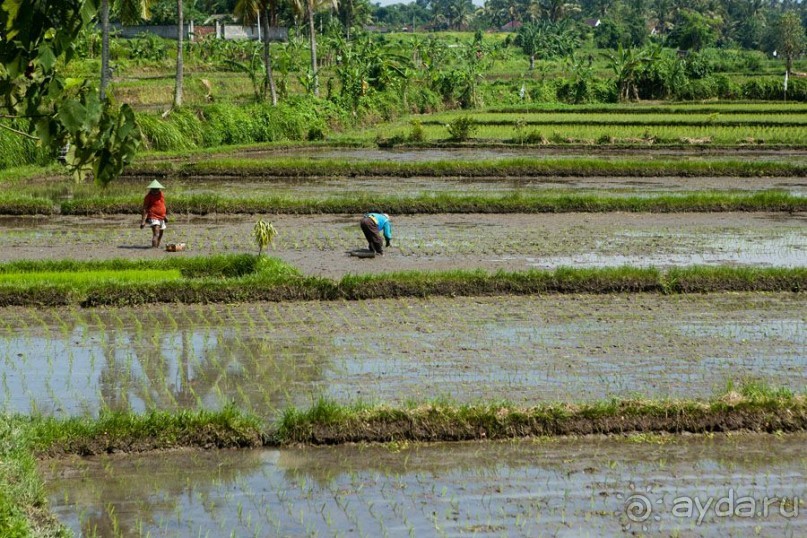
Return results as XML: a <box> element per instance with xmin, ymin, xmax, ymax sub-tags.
<box><xmin>100</xmin><ymin>307</ymin><xmax>328</xmax><ymax>417</ymax></box>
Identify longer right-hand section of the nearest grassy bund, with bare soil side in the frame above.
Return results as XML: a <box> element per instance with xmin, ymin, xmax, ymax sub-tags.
<box><xmin>269</xmin><ymin>384</ymin><xmax>807</xmax><ymax>445</ymax></box>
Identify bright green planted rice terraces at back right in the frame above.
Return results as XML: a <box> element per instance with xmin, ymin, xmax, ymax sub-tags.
<box><xmin>366</xmin><ymin>104</ymin><xmax>805</xmax><ymax>146</ymax></box>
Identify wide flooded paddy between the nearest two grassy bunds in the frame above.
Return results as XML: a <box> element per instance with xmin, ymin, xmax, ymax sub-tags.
<box><xmin>0</xmin><ymin>293</ymin><xmax>807</xmax><ymax>420</ymax></box>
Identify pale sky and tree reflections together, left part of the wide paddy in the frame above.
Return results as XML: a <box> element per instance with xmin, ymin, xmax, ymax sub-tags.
<box><xmin>0</xmin><ymin>307</ymin><xmax>329</xmax><ymax>419</ymax></box>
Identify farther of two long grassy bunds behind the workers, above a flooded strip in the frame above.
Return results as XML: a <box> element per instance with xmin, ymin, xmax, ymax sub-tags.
<box><xmin>126</xmin><ymin>157</ymin><xmax>807</xmax><ymax>178</ymax></box>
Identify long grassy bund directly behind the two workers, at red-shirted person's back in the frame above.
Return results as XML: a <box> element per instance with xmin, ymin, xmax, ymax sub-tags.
<box><xmin>61</xmin><ymin>191</ymin><xmax>807</xmax><ymax>215</ymax></box>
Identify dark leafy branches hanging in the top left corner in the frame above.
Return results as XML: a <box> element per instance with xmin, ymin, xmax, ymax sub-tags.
<box><xmin>0</xmin><ymin>0</ymin><xmax>140</xmax><ymax>185</ymax></box>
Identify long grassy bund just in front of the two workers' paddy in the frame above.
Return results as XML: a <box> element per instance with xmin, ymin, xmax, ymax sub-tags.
<box><xmin>0</xmin><ymin>256</ymin><xmax>807</xmax><ymax>307</ymax></box>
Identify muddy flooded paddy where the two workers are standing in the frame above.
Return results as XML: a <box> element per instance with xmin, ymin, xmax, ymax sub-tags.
<box><xmin>0</xmin><ymin>213</ymin><xmax>807</xmax><ymax>278</ymax></box>
